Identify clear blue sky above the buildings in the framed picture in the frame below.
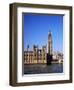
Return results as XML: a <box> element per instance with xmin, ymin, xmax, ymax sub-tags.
<box><xmin>23</xmin><ymin>13</ymin><xmax>63</xmax><ymax>52</ymax></box>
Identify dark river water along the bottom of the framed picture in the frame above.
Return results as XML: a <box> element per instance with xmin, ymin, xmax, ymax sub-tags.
<box><xmin>24</xmin><ymin>63</ymin><xmax>63</xmax><ymax>74</ymax></box>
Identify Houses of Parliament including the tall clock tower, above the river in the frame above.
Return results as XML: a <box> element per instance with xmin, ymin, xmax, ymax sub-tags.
<box><xmin>24</xmin><ymin>32</ymin><xmax>52</xmax><ymax>64</ymax></box>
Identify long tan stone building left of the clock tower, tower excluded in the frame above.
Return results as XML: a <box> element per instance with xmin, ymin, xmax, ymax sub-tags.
<box><xmin>24</xmin><ymin>45</ymin><xmax>47</xmax><ymax>64</ymax></box>
